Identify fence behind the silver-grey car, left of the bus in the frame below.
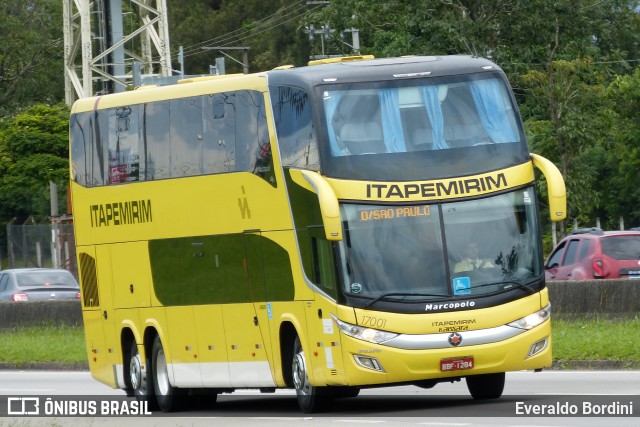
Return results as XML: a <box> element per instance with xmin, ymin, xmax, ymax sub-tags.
<box><xmin>2</xmin><ymin>217</ymin><xmax>77</xmax><ymax>277</ymax></box>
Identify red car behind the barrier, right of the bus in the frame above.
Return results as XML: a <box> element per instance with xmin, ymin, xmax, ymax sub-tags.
<box><xmin>545</xmin><ymin>227</ymin><xmax>640</xmax><ymax>280</ymax></box>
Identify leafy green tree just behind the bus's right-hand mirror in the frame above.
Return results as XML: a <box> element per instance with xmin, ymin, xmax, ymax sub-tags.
<box><xmin>523</xmin><ymin>59</ymin><xmax>613</xmax><ymax>231</ymax></box>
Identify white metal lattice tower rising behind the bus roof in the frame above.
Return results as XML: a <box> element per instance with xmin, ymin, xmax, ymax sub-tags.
<box><xmin>62</xmin><ymin>0</ymin><xmax>172</xmax><ymax>105</ymax></box>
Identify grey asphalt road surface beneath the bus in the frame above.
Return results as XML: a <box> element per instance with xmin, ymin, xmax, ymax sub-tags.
<box><xmin>0</xmin><ymin>370</ymin><xmax>640</xmax><ymax>427</ymax></box>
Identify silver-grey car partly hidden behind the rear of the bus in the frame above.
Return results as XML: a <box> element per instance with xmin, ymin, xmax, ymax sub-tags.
<box><xmin>0</xmin><ymin>268</ymin><xmax>80</xmax><ymax>301</ymax></box>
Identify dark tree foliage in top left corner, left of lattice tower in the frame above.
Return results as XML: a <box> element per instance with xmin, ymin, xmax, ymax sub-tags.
<box><xmin>0</xmin><ymin>0</ymin><xmax>64</xmax><ymax>116</ymax></box>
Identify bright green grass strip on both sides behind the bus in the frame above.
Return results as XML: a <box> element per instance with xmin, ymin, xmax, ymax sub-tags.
<box><xmin>0</xmin><ymin>317</ymin><xmax>640</xmax><ymax>368</ymax></box>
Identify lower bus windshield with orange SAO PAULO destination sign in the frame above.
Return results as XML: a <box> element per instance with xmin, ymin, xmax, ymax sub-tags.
<box><xmin>340</xmin><ymin>187</ymin><xmax>542</xmax><ymax>301</ymax></box>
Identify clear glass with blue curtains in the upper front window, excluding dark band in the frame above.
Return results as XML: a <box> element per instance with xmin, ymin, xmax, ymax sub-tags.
<box><xmin>323</xmin><ymin>78</ymin><xmax>520</xmax><ymax>157</ymax></box>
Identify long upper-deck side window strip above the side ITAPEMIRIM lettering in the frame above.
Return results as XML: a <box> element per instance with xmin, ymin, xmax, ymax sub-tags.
<box><xmin>70</xmin><ymin>90</ymin><xmax>276</xmax><ymax>187</ymax></box>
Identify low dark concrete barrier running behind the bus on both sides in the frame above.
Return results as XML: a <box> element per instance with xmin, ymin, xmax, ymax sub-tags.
<box><xmin>0</xmin><ymin>279</ymin><xmax>640</xmax><ymax>329</ymax></box>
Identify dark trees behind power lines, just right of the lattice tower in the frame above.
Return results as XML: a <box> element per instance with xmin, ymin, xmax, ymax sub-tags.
<box><xmin>167</xmin><ymin>0</ymin><xmax>309</xmax><ymax>74</ymax></box>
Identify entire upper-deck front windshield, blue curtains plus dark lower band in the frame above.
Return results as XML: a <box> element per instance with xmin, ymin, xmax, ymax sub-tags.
<box><xmin>315</xmin><ymin>72</ymin><xmax>530</xmax><ymax>181</ymax></box>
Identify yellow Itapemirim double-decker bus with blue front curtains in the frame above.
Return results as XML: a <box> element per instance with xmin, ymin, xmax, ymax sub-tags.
<box><xmin>70</xmin><ymin>56</ymin><xmax>565</xmax><ymax>412</ymax></box>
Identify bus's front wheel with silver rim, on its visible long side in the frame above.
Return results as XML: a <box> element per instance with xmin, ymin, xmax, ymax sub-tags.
<box><xmin>291</xmin><ymin>337</ymin><xmax>332</xmax><ymax>414</ymax></box>
